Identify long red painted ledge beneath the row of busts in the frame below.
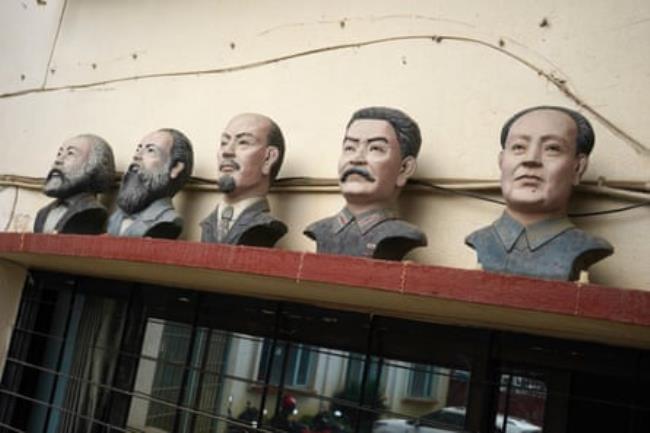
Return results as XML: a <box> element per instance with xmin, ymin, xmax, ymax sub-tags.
<box><xmin>0</xmin><ymin>233</ymin><xmax>650</xmax><ymax>327</ymax></box>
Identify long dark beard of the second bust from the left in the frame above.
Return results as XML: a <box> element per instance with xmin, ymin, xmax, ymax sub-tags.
<box><xmin>117</xmin><ymin>169</ymin><xmax>170</xmax><ymax>215</ymax></box>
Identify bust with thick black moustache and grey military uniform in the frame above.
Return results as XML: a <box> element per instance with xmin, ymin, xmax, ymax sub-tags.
<box><xmin>305</xmin><ymin>107</ymin><xmax>427</xmax><ymax>260</ymax></box>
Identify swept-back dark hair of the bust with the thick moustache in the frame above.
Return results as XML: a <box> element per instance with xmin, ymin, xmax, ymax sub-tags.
<box><xmin>346</xmin><ymin>107</ymin><xmax>422</xmax><ymax>159</ymax></box>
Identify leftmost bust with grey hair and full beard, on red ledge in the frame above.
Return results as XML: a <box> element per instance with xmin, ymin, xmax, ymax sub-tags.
<box><xmin>34</xmin><ymin>134</ymin><xmax>115</xmax><ymax>234</ymax></box>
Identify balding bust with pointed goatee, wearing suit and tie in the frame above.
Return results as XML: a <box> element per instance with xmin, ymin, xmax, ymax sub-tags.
<box><xmin>201</xmin><ymin>113</ymin><xmax>287</xmax><ymax>247</ymax></box>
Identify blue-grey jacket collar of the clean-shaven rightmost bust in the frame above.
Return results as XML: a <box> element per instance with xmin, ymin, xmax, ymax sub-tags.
<box><xmin>493</xmin><ymin>212</ymin><xmax>574</xmax><ymax>252</ymax></box>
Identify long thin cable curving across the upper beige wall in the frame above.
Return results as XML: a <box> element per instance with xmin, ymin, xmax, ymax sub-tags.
<box><xmin>0</xmin><ymin>32</ymin><xmax>650</xmax><ymax>158</ymax></box>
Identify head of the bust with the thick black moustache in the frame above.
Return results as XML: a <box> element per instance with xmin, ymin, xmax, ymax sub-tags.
<box><xmin>338</xmin><ymin>107</ymin><xmax>422</xmax><ymax>213</ymax></box>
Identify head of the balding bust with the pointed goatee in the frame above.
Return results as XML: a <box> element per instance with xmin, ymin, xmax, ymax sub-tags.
<box><xmin>217</xmin><ymin>113</ymin><xmax>284</xmax><ymax>202</ymax></box>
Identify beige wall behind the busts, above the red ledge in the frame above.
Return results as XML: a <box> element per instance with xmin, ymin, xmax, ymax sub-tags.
<box><xmin>0</xmin><ymin>0</ymin><xmax>650</xmax><ymax>290</ymax></box>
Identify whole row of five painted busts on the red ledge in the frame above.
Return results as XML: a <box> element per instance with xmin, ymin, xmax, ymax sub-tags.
<box><xmin>34</xmin><ymin>106</ymin><xmax>613</xmax><ymax>280</ymax></box>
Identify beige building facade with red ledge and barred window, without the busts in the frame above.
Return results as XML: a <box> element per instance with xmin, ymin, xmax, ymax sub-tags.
<box><xmin>0</xmin><ymin>0</ymin><xmax>650</xmax><ymax>433</ymax></box>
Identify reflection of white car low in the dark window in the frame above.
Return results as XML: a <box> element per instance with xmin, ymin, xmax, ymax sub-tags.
<box><xmin>372</xmin><ymin>407</ymin><xmax>542</xmax><ymax>433</ymax></box>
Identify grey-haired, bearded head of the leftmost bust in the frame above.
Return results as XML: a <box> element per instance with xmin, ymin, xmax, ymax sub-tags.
<box><xmin>43</xmin><ymin>134</ymin><xmax>115</xmax><ymax>199</ymax></box>
